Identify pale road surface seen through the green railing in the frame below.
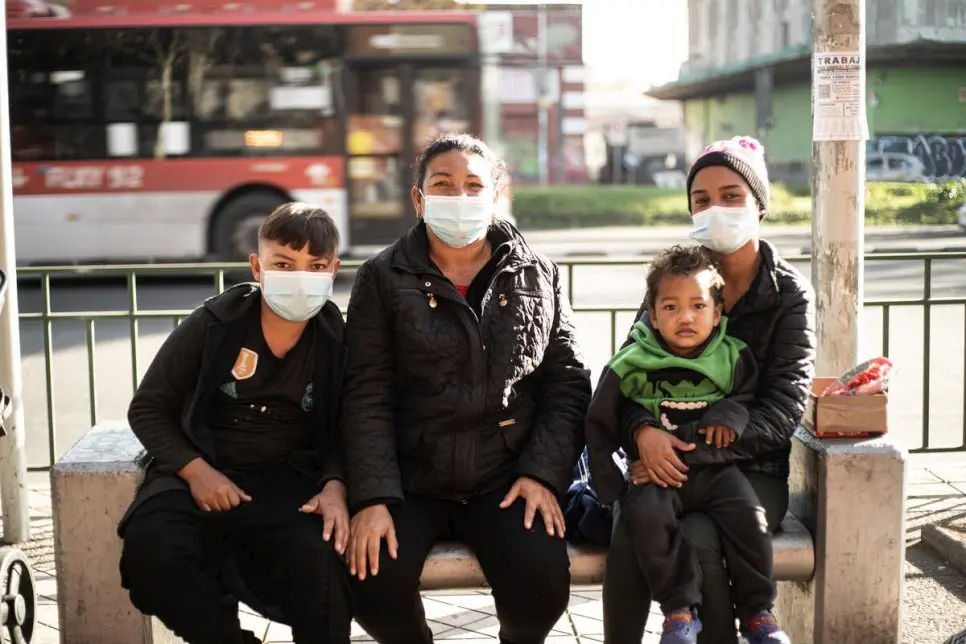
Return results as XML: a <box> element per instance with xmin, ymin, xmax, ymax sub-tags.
<box><xmin>9</xmin><ymin>231</ymin><xmax>966</xmax><ymax>467</ymax></box>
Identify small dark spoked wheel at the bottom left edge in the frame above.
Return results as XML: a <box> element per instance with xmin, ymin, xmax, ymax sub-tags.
<box><xmin>0</xmin><ymin>547</ymin><xmax>37</xmax><ymax>644</ymax></box>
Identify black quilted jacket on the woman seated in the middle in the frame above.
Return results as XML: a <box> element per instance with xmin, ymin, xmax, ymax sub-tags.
<box><xmin>341</xmin><ymin>222</ymin><xmax>590</xmax><ymax>510</ymax></box>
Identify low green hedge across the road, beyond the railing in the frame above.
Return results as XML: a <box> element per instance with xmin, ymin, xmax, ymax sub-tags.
<box><xmin>513</xmin><ymin>179</ymin><xmax>966</xmax><ymax>230</ymax></box>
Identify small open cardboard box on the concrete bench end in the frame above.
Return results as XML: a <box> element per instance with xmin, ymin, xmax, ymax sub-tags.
<box><xmin>802</xmin><ymin>378</ymin><xmax>889</xmax><ymax>438</ymax></box>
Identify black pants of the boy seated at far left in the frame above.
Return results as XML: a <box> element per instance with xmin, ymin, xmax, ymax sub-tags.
<box><xmin>121</xmin><ymin>468</ymin><xmax>352</xmax><ymax>644</ymax></box>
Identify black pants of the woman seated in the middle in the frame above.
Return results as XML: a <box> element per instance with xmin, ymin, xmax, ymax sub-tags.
<box><xmin>353</xmin><ymin>488</ymin><xmax>570</xmax><ymax>644</ymax></box>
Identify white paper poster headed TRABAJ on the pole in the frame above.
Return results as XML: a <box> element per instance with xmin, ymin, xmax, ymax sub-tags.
<box><xmin>812</xmin><ymin>51</ymin><xmax>869</xmax><ymax>141</ymax></box>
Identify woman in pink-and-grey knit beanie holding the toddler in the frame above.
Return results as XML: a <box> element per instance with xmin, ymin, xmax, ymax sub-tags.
<box><xmin>585</xmin><ymin>137</ymin><xmax>815</xmax><ymax>644</ymax></box>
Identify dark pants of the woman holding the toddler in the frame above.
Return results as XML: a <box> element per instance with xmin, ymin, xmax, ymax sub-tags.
<box><xmin>604</xmin><ymin>472</ymin><xmax>788</xmax><ymax>644</ymax></box>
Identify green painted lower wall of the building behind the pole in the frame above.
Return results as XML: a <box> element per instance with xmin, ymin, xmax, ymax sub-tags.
<box><xmin>684</xmin><ymin>67</ymin><xmax>966</xmax><ymax>163</ymax></box>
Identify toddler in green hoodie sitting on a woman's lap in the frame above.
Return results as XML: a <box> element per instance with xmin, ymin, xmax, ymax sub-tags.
<box><xmin>600</xmin><ymin>246</ymin><xmax>787</xmax><ymax>644</ymax></box>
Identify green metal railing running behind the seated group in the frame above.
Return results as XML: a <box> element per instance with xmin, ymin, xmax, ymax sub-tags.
<box><xmin>18</xmin><ymin>252</ymin><xmax>966</xmax><ymax>470</ymax></box>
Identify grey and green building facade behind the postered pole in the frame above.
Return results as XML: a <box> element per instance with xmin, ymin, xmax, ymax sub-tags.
<box><xmin>649</xmin><ymin>0</ymin><xmax>966</xmax><ymax>181</ymax></box>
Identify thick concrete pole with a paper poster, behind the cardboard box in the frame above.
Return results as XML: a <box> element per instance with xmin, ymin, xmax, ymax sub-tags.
<box><xmin>812</xmin><ymin>0</ymin><xmax>868</xmax><ymax>376</ymax></box>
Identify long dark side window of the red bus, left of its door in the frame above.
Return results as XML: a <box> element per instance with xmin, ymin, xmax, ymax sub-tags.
<box><xmin>9</xmin><ymin>25</ymin><xmax>344</xmax><ymax>161</ymax></box>
